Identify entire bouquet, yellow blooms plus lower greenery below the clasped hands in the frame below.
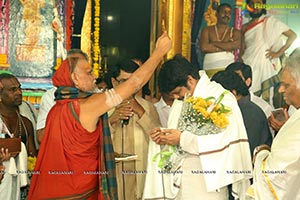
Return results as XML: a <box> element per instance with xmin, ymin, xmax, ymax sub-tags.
<box><xmin>153</xmin><ymin>91</ymin><xmax>231</xmax><ymax>172</ymax></box>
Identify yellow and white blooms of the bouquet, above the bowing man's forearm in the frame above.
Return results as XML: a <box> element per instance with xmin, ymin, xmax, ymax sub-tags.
<box><xmin>178</xmin><ymin>91</ymin><xmax>231</xmax><ymax>135</ymax></box>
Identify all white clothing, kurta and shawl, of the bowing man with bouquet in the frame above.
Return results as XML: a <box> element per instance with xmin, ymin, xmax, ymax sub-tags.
<box><xmin>144</xmin><ymin>71</ymin><xmax>252</xmax><ymax>200</ymax></box>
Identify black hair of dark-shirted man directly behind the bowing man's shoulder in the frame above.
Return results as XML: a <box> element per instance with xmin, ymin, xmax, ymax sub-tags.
<box><xmin>211</xmin><ymin>70</ymin><xmax>249</xmax><ymax>96</ymax></box>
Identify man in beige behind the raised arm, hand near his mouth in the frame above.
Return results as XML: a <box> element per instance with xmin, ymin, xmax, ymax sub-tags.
<box><xmin>108</xmin><ymin>59</ymin><xmax>159</xmax><ymax>200</ymax></box>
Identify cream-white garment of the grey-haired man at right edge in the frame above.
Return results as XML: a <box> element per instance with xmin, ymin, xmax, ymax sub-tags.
<box><xmin>253</xmin><ymin>109</ymin><xmax>300</xmax><ymax>200</ymax></box>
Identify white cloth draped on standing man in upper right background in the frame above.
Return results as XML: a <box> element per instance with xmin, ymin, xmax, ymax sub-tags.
<box><xmin>242</xmin><ymin>15</ymin><xmax>289</xmax><ymax>93</ymax></box>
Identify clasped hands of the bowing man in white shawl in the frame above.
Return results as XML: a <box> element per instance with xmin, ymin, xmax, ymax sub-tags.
<box><xmin>150</xmin><ymin>128</ymin><xmax>181</xmax><ymax>145</ymax></box>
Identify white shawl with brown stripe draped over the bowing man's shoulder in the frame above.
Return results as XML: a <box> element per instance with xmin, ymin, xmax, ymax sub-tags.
<box><xmin>193</xmin><ymin>71</ymin><xmax>252</xmax><ymax>197</ymax></box>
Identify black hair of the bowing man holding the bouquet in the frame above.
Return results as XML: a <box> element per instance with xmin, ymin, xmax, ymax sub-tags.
<box><xmin>158</xmin><ymin>54</ymin><xmax>200</xmax><ymax>93</ymax></box>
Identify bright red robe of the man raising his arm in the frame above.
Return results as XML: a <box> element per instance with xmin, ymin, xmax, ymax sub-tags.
<box><xmin>28</xmin><ymin>99</ymin><xmax>102</xmax><ymax>200</ymax></box>
